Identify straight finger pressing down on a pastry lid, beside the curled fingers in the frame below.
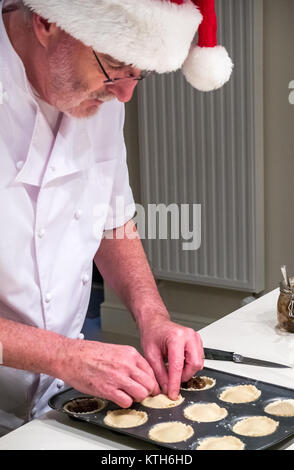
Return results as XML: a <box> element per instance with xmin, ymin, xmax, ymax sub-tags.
<box><xmin>168</xmin><ymin>338</ymin><xmax>185</xmax><ymax>400</ymax></box>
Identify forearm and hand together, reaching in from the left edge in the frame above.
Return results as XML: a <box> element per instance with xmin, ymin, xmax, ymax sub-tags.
<box><xmin>0</xmin><ymin>318</ymin><xmax>160</xmax><ymax>408</ymax></box>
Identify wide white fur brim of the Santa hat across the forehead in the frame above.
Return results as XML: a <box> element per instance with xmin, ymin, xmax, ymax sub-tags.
<box><xmin>24</xmin><ymin>0</ymin><xmax>202</xmax><ymax>73</ymax></box>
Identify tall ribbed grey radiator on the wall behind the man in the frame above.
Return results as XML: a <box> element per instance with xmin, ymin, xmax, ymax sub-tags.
<box><xmin>138</xmin><ymin>0</ymin><xmax>264</xmax><ymax>293</ymax></box>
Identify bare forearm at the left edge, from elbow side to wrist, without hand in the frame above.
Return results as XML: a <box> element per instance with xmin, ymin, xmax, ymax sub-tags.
<box><xmin>0</xmin><ymin>317</ymin><xmax>72</xmax><ymax>377</ymax></box>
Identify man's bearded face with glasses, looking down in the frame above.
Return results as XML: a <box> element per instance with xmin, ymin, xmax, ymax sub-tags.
<box><xmin>46</xmin><ymin>31</ymin><xmax>140</xmax><ymax>118</ymax></box>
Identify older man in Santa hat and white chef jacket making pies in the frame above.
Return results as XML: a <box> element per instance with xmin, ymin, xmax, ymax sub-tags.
<box><xmin>0</xmin><ymin>0</ymin><xmax>233</xmax><ymax>433</ymax></box>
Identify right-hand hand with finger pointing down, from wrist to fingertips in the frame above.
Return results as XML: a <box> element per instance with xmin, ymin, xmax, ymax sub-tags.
<box><xmin>141</xmin><ymin>317</ymin><xmax>204</xmax><ymax>400</ymax></box>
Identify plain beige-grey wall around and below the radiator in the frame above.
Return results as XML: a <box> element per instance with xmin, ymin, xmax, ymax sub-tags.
<box><xmin>102</xmin><ymin>0</ymin><xmax>294</xmax><ymax>334</ymax></box>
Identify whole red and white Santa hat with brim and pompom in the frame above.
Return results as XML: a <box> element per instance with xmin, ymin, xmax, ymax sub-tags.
<box><xmin>23</xmin><ymin>0</ymin><xmax>233</xmax><ymax>91</ymax></box>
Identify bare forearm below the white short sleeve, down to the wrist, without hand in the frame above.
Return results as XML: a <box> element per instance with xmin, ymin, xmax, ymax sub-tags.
<box><xmin>95</xmin><ymin>221</ymin><xmax>169</xmax><ymax>328</ymax></box>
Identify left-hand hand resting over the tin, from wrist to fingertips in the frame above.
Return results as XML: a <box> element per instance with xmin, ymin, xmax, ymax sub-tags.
<box><xmin>58</xmin><ymin>340</ymin><xmax>160</xmax><ymax>408</ymax></box>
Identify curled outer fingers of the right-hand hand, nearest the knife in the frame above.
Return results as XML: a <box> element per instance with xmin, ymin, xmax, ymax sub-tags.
<box><xmin>182</xmin><ymin>333</ymin><xmax>204</xmax><ymax>382</ymax></box>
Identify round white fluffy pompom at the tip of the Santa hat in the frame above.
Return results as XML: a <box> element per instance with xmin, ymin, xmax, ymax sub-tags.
<box><xmin>183</xmin><ymin>46</ymin><xmax>234</xmax><ymax>91</ymax></box>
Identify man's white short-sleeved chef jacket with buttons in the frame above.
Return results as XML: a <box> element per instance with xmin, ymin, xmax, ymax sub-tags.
<box><xmin>0</xmin><ymin>2</ymin><xmax>135</xmax><ymax>435</ymax></box>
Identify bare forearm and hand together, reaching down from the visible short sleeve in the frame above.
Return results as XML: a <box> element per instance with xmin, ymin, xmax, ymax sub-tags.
<box><xmin>95</xmin><ymin>220</ymin><xmax>204</xmax><ymax>399</ymax></box>
